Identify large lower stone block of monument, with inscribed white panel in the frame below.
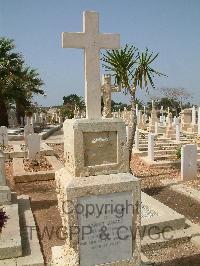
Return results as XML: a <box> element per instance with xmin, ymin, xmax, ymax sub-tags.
<box><xmin>52</xmin><ymin>168</ymin><xmax>141</xmax><ymax>266</ymax></box>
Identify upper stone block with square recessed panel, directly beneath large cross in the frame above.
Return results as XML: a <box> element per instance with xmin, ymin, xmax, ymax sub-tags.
<box><xmin>63</xmin><ymin>118</ymin><xmax>129</xmax><ymax>177</ymax></box>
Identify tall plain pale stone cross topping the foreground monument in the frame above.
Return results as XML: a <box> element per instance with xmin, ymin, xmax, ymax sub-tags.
<box><xmin>62</xmin><ymin>11</ymin><xmax>120</xmax><ymax>119</ymax></box>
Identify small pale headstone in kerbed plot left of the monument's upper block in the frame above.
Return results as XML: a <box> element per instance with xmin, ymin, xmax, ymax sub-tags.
<box><xmin>27</xmin><ymin>133</ymin><xmax>40</xmax><ymax>160</ymax></box>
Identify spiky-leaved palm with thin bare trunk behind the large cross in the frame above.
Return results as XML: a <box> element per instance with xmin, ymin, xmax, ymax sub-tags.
<box><xmin>102</xmin><ymin>45</ymin><xmax>165</xmax><ymax>161</ymax></box>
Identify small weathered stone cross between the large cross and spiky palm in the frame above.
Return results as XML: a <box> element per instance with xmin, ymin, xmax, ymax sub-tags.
<box><xmin>101</xmin><ymin>75</ymin><xmax>121</xmax><ymax>118</ymax></box>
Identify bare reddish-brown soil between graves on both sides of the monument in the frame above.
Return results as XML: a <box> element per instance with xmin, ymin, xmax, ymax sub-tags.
<box><xmin>6</xmin><ymin>132</ymin><xmax>200</xmax><ymax>266</ymax></box>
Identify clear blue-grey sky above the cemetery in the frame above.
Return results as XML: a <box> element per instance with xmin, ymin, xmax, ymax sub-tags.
<box><xmin>0</xmin><ymin>0</ymin><xmax>200</xmax><ymax>106</ymax></box>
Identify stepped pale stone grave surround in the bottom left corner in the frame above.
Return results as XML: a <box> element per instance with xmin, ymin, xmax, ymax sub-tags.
<box><xmin>0</xmin><ymin>195</ymin><xmax>44</xmax><ymax>266</ymax></box>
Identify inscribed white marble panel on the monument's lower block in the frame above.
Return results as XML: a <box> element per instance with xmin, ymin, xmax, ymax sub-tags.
<box><xmin>78</xmin><ymin>192</ymin><xmax>133</xmax><ymax>266</ymax></box>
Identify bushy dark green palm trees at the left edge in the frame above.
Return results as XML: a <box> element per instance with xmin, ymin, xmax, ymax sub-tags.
<box><xmin>0</xmin><ymin>38</ymin><xmax>44</xmax><ymax>126</ymax></box>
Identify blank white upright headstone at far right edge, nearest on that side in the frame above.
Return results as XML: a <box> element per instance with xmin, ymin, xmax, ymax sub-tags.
<box><xmin>181</xmin><ymin>144</ymin><xmax>197</xmax><ymax>181</ymax></box>
